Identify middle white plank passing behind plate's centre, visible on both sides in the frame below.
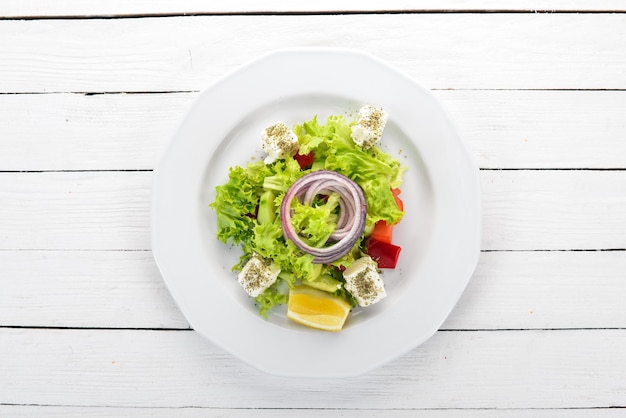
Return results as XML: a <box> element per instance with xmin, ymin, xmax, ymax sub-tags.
<box><xmin>0</xmin><ymin>170</ymin><xmax>626</xmax><ymax>250</ymax></box>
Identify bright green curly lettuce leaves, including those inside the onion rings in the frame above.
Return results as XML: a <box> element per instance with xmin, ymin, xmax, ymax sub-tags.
<box><xmin>209</xmin><ymin>112</ymin><xmax>405</xmax><ymax>317</ymax></box>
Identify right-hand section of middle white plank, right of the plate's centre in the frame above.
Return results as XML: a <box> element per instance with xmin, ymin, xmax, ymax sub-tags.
<box><xmin>481</xmin><ymin>170</ymin><xmax>626</xmax><ymax>250</ymax></box>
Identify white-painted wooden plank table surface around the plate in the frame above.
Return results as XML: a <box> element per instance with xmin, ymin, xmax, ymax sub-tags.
<box><xmin>0</xmin><ymin>0</ymin><xmax>626</xmax><ymax>417</ymax></box>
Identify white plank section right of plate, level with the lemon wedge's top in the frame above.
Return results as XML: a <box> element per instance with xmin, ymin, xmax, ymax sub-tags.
<box><xmin>441</xmin><ymin>251</ymin><xmax>626</xmax><ymax>330</ymax></box>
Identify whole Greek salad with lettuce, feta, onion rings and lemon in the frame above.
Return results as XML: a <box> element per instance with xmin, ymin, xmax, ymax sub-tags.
<box><xmin>209</xmin><ymin>105</ymin><xmax>406</xmax><ymax>331</ymax></box>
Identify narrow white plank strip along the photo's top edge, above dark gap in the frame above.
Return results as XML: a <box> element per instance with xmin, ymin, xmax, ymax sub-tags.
<box><xmin>2</xmin><ymin>0</ymin><xmax>626</xmax><ymax>18</ymax></box>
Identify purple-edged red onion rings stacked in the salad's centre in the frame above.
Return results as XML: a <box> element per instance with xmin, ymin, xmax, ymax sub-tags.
<box><xmin>280</xmin><ymin>170</ymin><xmax>367</xmax><ymax>264</ymax></box>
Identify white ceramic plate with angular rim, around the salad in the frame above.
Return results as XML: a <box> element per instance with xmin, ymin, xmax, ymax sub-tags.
<box><xmin>152</xmin><ymin>48</ymin><xmax>481</xmax><ymax>377</ymax></box>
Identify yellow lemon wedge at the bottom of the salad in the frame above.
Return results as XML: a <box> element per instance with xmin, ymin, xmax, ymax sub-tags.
<box><xmin>287</xmin><ymin>286</ymin><xmax>350</xmax><ymax>332</ymax></box>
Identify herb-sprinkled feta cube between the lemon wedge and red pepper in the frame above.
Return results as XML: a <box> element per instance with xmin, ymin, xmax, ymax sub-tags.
<box><xmin>343</xmin><ymin>256</ymin><xmax>387</xmax><ymax>306</ymax></box>
